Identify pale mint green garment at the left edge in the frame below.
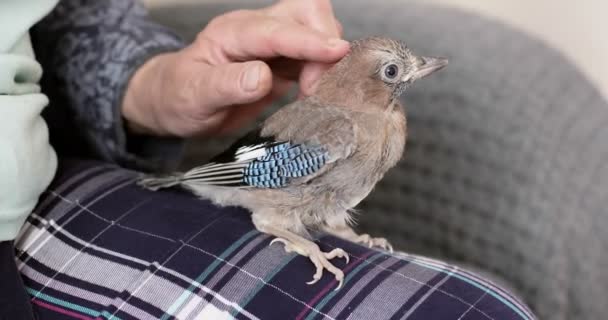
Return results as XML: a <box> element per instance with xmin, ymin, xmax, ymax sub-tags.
<box><xmin>0</xmin><ymin>0</ymin><xmax>57</xmax><ymax>241</ymax></box>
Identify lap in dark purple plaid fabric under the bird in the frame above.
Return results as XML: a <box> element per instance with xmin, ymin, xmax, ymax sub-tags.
<box><xmin>16</xmin><ymin>161</ymin><xmax>533</xmax><ymax>319</ymax></box>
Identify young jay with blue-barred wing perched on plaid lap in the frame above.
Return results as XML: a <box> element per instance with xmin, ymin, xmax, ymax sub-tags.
<box><xmin>138</xmin><ymin>37</ymin><xmax>448</xmax><ymax>290</ymax></box>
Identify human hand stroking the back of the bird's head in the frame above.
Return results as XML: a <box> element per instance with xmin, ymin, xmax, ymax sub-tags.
<box><xmin>122</xmin><ymin>0</ymin><xmax>349</xmax><ymax>137</ymax></box>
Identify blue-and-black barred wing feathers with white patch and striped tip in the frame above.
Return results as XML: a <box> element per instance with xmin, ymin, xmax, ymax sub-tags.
<box><xmin>183</xmin><ymin>134</ymin><xmax>328</xmax><ymax>188</ymax></box>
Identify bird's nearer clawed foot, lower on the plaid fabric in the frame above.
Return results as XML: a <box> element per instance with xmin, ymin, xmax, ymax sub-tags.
<box><xmin>270</xmin><ymin>238</ymin><xmax>349</xmax><ymax>290</ymax></box>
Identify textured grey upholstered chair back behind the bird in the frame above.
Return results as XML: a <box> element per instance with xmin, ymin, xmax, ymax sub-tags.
<box><xmin>148</xmin><ymin>0</ymin><xmax>608</xmax><ymax>319</ymax></box>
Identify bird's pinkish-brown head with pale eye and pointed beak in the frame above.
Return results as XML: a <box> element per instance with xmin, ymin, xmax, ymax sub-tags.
<box><xmin>317</xmin><ymin>37</ymin><xmax>448</xmax><ymax>107</ymax></box>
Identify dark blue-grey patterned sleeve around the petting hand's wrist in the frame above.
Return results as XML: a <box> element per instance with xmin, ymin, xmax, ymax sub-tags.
<box><xmin>31</xmin><ymin>0</ymin><xmax>183</xmax><ymax>170</ymax></box>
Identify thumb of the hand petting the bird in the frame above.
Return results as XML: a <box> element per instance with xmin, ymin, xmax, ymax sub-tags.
<box><xmin>198</xmin><ymin>61</ymin><xmax>272</xmax><ymax>111</ymax></box>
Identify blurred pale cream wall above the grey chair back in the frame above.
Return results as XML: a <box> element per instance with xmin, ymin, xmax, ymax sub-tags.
<box><xmin>144</xmin><ymin>0</ymin><xmax>608</xmax><ymax>98</ymax></box>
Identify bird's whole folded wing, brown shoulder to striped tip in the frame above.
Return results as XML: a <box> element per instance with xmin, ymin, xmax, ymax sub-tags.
<box><xmin>181</xmin><ymin>101</ymin><xmax>354</xmax><ymax>188</ymax></box>
